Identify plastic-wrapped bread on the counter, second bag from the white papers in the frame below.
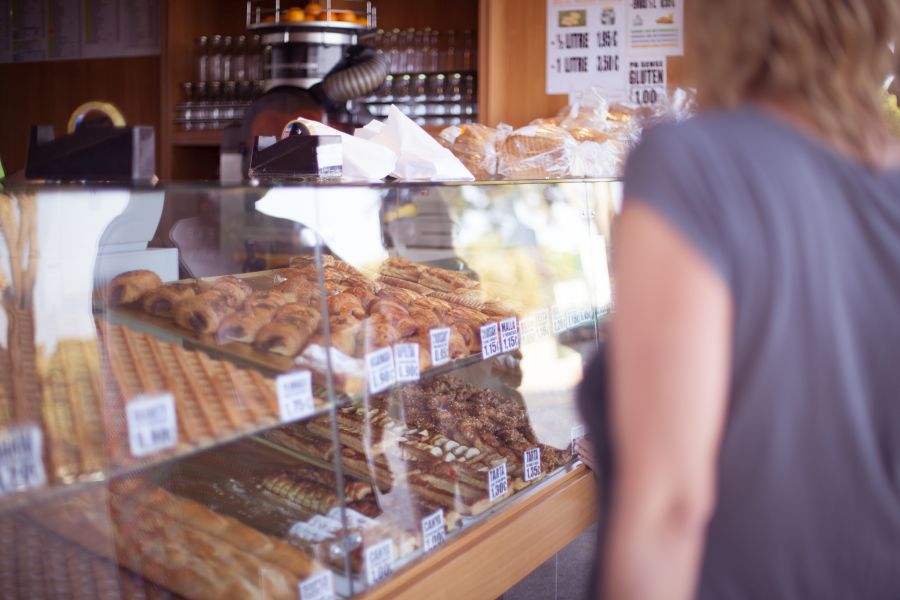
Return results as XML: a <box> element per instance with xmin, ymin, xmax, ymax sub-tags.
<box><xmin>497</xmin><ymin>125</ymin><xmax>578</xmax><ymax>179</ymax></box>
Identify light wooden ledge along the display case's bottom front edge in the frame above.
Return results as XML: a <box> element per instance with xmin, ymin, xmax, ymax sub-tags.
<box><xmin>360</xmin><ymin>465</ymin><xmax>596</xmax><ymax>600</ymax></box>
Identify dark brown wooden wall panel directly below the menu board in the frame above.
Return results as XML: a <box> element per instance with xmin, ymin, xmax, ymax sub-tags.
<box><xmin>0</xmin><ymin>56</ymin><xmax>160</xmax><ymax>175</ymax></box>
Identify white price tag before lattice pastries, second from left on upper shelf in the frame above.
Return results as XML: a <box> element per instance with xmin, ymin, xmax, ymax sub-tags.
<box><xmin>125</xmin><ymin>393</ymin><xmax>178</xmax><ymax>458</ymax></box>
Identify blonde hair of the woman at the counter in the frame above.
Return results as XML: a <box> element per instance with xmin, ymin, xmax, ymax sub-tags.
<box><xmin>686</xmin><ymin>0</ymin><xmax>900</xmax><ymax>164</ymax></box>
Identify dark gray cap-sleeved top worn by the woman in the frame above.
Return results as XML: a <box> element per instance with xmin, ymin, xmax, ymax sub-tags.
<box><xmin>625</xmin><ymin>107</ymin><xmax>900</xmax><ymax>600</ymax></box>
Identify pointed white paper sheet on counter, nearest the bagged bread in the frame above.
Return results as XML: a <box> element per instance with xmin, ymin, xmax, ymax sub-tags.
<box><xmin>362</xmin><ymin>105</ymin><xmax>475</xmax><ymax>181</ymax></box>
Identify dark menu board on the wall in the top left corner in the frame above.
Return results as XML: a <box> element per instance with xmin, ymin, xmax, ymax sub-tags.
<box><xmin>0</xmin><ymin>0</ymin><xmax>160</xmax><ymax>63</ymax></box>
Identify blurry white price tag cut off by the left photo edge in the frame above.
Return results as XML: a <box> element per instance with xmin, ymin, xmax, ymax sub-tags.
<box><xmin>0</xmin><ymin>425</ymin><xmax>47</xmax><ymax>496</ymax></box>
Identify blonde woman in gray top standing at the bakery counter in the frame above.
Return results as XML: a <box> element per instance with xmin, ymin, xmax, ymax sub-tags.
<box><xmin>583</xmin><ymin>0</ymin><xmax>900</xmax><ymax>600</ymax></box>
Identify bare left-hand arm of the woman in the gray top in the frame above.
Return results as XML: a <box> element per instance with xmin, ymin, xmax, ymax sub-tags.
<box><xmin>602</xmin><ymin>202</ymin><xmax>732</xmax><ymax>600</ymax></box>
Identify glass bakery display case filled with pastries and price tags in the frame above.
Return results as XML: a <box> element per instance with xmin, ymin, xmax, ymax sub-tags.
<box><xmin>0</xmin><ymin>180</ymin><xmax>621</xmax><ymax>600</ymax></box>
